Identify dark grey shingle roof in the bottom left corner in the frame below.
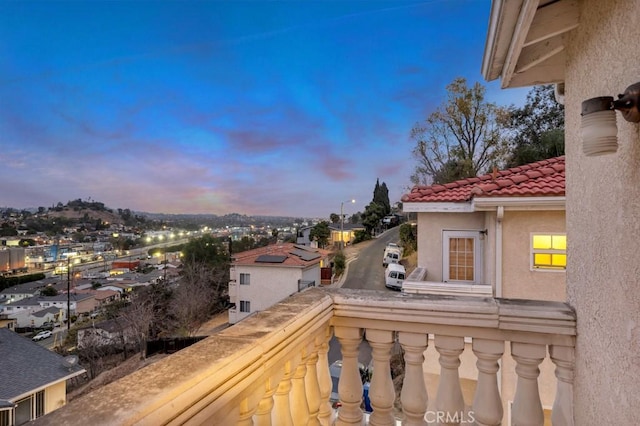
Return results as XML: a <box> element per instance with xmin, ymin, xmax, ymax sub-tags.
<box><xmin>0</xmin><ymin>328</ymin><xmax>85</xmax><ymax>405</ymax></box>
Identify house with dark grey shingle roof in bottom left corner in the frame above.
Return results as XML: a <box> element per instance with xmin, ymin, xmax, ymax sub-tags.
<box><xmin>0</xmin><ymin>328</ymin><xmax>85</xmax><ymax>425</ymax></box>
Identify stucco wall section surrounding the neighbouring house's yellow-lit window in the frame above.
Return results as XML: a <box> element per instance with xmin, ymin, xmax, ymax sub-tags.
<box><xmin>502</xmin><ymin>211</ymin><xmax>566</xmax><ymax>302</ymax></box>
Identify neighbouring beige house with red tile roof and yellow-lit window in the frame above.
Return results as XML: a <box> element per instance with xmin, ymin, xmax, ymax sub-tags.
<box><xmin>402</xmin><ymin>157</ymin><xmax>567</xmax><ymax>301</ymax></box>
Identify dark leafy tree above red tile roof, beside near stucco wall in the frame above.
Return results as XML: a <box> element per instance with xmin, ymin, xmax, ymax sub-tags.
<box><xmin>507</xmin><ymin>85</ymin><xmax>564</xmax><ymax>167</ymax></box>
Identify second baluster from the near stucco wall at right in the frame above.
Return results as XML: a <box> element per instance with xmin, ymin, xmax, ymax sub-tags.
<box><xmin>511</xmin><ymin>342</ymin><xmax>547</xmax><ymax>426</ymax></box>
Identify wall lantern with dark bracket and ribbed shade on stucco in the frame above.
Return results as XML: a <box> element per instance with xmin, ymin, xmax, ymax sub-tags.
<box><xmin>580</xmin><ymin>82</ymin><xmax>640</xmax><ymax>157</ymax></box>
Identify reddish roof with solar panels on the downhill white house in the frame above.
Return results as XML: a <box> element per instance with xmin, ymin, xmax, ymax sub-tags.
<box><xmin>232</xmin><ymin>243</ymin><xmax>329</xmax><ymax>267</ymax></box>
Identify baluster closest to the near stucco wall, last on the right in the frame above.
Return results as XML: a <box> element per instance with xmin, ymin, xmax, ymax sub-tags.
<box><xmin>549</xmin><ymin>345</ymin><xmax>575</xmax><ymax>426</ymax></box>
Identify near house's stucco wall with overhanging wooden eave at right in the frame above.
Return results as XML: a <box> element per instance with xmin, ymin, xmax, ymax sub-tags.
<box><xmin>482</xmin><ymin>0</ymin><xmax>640</xmax><ymax>425</ymax></box>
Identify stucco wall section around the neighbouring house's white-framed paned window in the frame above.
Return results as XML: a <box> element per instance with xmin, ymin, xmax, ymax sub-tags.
<box><xmin>418</xmin><ymin>213</ymin><xmax>488</xmax><ymax>283</ymax></box>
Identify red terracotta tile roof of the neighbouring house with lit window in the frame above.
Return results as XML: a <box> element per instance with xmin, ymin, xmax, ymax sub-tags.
<box><xmin>402</xmin><ymin>156</ymin><xmax>565</xmax><ymax>203</ymax></box>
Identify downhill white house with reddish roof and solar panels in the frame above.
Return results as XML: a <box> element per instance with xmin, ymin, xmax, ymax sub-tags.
<box><xmin>229</xmin><ymin>243</ymin><xmax>328</xmax><ymax>324</ymax></box>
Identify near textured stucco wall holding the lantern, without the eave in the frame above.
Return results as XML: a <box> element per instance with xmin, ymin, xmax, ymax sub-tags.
<box><xmin>565</xmin><ymin>0</ymin><xmax>640</xmax><ymax>425</ymax></box>
